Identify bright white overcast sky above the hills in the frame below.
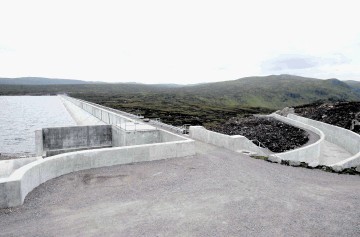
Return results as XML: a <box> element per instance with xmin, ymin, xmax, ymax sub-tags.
<box><xmin>0</xmin><ymin>0</ymin><xmax>360</xmax><ymax>84</ymax></box>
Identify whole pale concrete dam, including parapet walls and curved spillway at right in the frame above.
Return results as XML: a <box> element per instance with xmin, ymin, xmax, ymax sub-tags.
<box><xmin>0</xmin><ymin>95</ymin><xmax>360</xmax><ymax>207</ymax></box>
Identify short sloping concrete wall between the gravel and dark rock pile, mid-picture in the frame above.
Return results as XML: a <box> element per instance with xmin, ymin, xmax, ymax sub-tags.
<box><xmin>189</xmin><ymin>126</ymin><xmax>266</xmax><ymax>155</ymax></box>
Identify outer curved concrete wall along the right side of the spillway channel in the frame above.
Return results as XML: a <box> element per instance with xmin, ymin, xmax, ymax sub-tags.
<box><xmin>288</xmin><ymin>114</ymin><xmax>360</xmax><ymax>171</ymax></box>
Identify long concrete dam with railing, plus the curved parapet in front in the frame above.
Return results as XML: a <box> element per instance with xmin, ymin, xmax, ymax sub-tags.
<box><xmin>0</xmin><ymin>97</ymin><xmax>195</xmax><ymax>208</ymax></box>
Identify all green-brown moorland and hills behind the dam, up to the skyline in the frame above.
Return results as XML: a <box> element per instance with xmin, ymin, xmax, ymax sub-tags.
<box><xmin>0</xmin><ymin>75</ymin><xmax>360</xmax><ymax>127</ymax></box>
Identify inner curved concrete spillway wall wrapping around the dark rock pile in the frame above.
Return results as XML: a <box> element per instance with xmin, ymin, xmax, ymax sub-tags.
<box><xmin>269</xmin><ymin>114</ymin><xmax>325</xmax><ymax>163</ymax></box>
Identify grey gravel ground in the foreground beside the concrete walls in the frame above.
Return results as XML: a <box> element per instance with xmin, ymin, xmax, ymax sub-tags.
<box><xmin>0</xmin><ymin>143</ymin><xmax>360</xmax><ymax>236</ymax></box>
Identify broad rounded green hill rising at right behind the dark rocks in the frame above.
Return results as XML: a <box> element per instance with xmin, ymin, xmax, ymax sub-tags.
<box><xmin>182</xmin><ymin>75</ymin><xmax>360</xmax><ymax>108</ymax></box>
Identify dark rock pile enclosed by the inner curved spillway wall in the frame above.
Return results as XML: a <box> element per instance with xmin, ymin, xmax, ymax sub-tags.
<box><xmin>212</xmin><ymin>116</ymin><xmax>309</xmax><ymax>152</ymax></box>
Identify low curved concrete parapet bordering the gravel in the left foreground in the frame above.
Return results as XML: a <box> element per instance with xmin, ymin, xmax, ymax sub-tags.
<box><xmin>0</xmin><ymin>139</ymin><xmax>195</xmax><ymax>208</ymax></box>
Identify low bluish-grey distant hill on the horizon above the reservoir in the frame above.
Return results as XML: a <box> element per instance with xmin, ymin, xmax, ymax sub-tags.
<box><xmin>0</xmin><ymin>77</ymin><xmax>101</xmax><ymax>85</ymax></box>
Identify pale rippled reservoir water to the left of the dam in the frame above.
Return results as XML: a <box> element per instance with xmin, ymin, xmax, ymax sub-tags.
<box><xmin>0</xmin><ymin>96</ymin><xmax>76</xmax><ymax>156</ymax></box>
